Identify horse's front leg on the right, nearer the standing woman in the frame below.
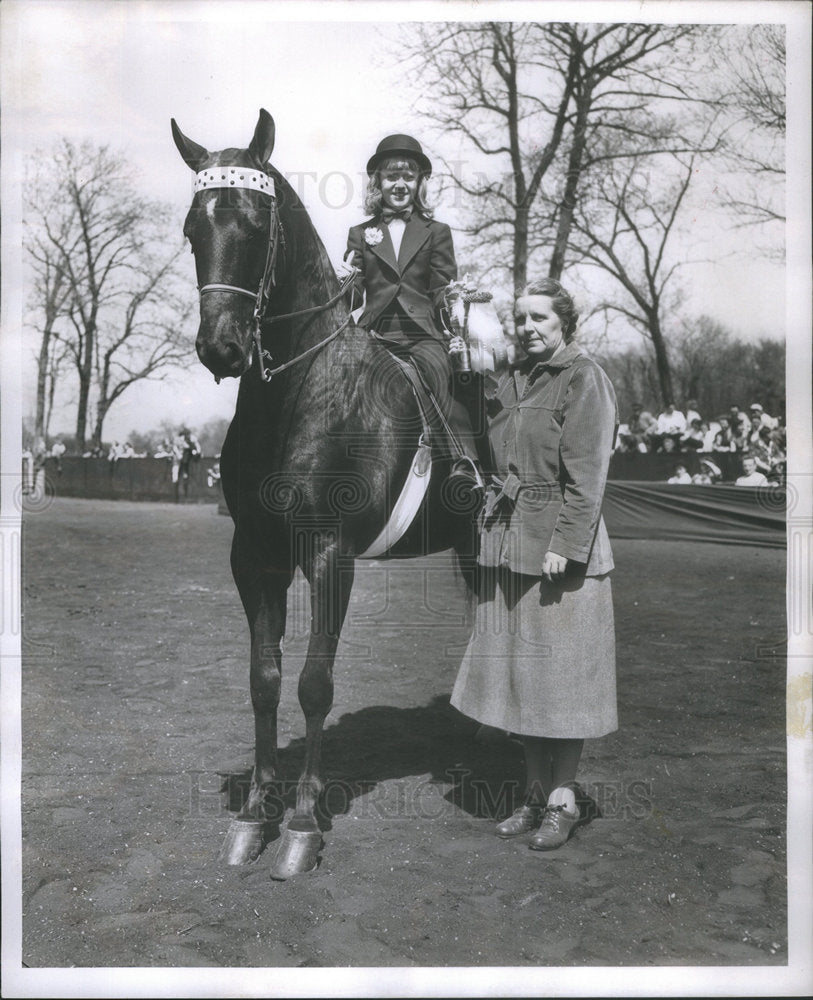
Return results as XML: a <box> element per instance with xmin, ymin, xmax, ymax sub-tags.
<box><xmin>271</xmin><ymin>544</ymin><xmax>354</xmax><ymax>879</ymax></box>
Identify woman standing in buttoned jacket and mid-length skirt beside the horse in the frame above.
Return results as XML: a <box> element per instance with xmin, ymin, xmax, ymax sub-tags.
<box><xmin>452</xmin><ymin>278</ymin><xmax>618</xmax><ymax>850</ymax></box>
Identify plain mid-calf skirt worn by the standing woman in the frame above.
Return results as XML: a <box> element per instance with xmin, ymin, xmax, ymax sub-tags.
<box><xmin>452</xmin><ymin>567</ymin><xmax>618</xmax><ymax>739</ymax></box>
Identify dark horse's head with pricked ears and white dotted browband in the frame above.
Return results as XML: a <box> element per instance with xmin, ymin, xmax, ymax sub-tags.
<box><xmin>172</xmin><ymin>110</ymin><xmax>280</xmax><ymax>379</ymax></box>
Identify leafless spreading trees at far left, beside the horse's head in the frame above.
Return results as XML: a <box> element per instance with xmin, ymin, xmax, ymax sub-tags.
<box><xmin>26</xmin><ymin>140</ymin><xmax>189</xmax><ymax>451</ymax></box>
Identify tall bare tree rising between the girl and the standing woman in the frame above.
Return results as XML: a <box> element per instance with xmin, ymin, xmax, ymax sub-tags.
<box><xmin>402</xmin><ymin>21</ymin><xmax>577</xmax><ymax>287</ymax></box>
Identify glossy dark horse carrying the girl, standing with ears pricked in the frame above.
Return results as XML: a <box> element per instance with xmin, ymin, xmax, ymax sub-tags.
<box><xmin>172</xmin><ymin>110</ymin><xmax>476</xmax><ymax>878</ymax></box>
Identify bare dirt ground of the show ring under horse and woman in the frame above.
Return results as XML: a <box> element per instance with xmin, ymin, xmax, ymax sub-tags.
<box><xmin>17</xmin><ymin>499</ymin><xmax>787</xmax><ymax>980</ymax></box>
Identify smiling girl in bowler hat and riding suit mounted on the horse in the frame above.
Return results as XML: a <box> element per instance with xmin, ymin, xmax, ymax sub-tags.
<box><xmin>336</xmin><ymin>135</ymin><xmax>482</xmax><ymax>487</ymax></box>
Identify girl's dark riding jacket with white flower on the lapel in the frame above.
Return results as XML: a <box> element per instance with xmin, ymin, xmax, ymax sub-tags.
<box><xmin>347</xmin><ymin>211</ymin><xmax>457</xmax><ymax>340</ymax></box>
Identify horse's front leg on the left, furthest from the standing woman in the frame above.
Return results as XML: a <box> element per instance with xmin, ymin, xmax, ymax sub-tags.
<box><xmin>220</xmin><ymin>565</ymin><xmax>291</xmax><ymax>865</ymax></box>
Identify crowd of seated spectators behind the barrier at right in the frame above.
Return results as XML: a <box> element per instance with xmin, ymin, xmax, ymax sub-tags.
<box><xmin>616</xmin><ymin>399</ymin><xmax>787</xmax><ymax>486</ymax></box>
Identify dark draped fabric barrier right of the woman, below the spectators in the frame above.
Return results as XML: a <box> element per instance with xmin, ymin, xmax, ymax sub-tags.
<box><xmin>603</xmin><ymin>482</ymin><xmax>786</xmax><ymax>548</ymax></box>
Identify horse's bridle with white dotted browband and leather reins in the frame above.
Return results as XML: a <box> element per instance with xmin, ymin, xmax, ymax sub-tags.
<box><xmin>194</xmin><ymin>165</ymin><xmax>353</xmax><ymax>382</ymax></box>
